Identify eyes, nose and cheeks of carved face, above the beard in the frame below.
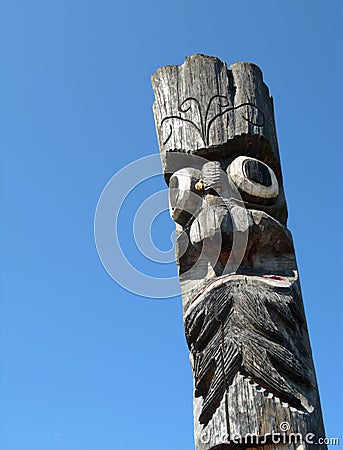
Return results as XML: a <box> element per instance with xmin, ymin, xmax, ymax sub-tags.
<box><xmin>169</xmin><ymin>156</ymin><xmax>296</xmax><ymax>302</ymax></box>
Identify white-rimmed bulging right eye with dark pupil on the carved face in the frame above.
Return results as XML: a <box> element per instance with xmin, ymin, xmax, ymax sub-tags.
<box><xmin>227</xmin><ymin>156</ymin><xmax>279</xmax><ymax>204</ymax></box>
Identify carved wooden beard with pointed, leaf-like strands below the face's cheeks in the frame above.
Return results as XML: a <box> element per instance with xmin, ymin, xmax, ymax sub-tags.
<box><xmin>185</xmin><ymin>276</ymin><xmax>312</xmax><ymax>425</ymax></box>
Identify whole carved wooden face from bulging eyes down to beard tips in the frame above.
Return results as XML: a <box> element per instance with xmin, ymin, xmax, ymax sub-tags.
<box><xmin>169</xmin><ymin>156</ymin><xmax>314</xmax><ymax>427</ymax></box>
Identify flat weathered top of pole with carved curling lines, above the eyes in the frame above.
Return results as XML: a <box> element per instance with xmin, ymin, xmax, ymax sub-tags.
<box><xmin>152</xmin><ymin>55</ymin><xmax>280</xmax><ymax>181</ymax></box>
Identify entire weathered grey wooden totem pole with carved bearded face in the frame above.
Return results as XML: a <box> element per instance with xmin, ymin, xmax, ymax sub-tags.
<box><xmin>152</xmin><ymin>55</ymin><xmax>326</xmax><ymax>450</ymax></box>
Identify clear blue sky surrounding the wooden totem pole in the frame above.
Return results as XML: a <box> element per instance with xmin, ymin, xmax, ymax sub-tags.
<box><xmin>0</xmin><ymin>0</ymin><xmax>343</xmax><ymax>450</ymax></box>
